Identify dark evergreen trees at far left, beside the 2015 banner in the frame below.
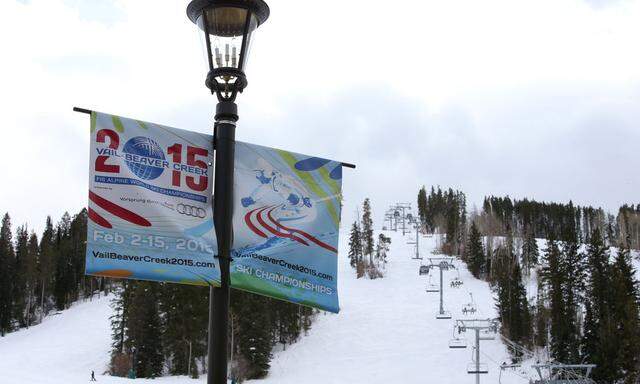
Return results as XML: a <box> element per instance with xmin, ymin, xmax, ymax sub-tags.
<box><xmin>0</xmin><ymin>209</ymin><xmax>108</xmax><ymax>336</ymax></box>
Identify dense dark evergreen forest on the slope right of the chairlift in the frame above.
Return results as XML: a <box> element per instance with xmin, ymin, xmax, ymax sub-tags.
<box><xmin>418</xmin><ymin>188</ymin><xmax>640</xmax><ymax>384</ymax></box>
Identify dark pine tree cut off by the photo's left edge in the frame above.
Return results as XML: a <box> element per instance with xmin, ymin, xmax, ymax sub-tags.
<box><xmin>0</xmin><ymin>213</ymin><xmax>15</xmax><ymax>336</ymax></box>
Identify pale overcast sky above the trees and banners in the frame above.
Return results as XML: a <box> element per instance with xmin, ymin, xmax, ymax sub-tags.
<box><xmin>0</xmin><ymin>0</ymin><xmax>640</xmax><ymax>236</ymax></box>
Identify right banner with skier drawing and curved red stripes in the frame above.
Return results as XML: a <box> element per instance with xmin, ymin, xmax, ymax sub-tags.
<box><xmin>231</xmin><ymin>142</ymin><xmax>342</xmax><ymax>312</ymax></box>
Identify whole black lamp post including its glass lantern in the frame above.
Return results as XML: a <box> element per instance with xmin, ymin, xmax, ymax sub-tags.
<box><xmin>187</xmin><ymin>0</ymin><xmax>269</xmax><ymax>384</ymax></box>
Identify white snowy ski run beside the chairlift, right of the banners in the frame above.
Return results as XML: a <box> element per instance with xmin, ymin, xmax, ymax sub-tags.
<box><xmin>252</xmin><ymin>232</ymin><xmax>528</xmax><ymax>384</ymax></box>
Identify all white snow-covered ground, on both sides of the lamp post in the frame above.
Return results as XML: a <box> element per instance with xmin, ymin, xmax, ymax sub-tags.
<box><xmin>0</xmin><ymin>229</ymin><xmax>640</xmax><ymax>384</ymax></box>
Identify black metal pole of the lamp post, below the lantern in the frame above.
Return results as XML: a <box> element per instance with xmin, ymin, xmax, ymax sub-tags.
<box><xmin>207</xmin><ymin>100</ymin><xmax>238</xmax><ymax>384</ymax></box>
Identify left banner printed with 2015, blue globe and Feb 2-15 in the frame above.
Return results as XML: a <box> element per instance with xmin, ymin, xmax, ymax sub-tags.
<box><xmin>86</xmin><ymin>112</ymin><xmax>220</xmax><ymax>285</ymax></box>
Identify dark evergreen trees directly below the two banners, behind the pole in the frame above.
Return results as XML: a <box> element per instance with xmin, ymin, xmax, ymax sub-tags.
<box><xmin>110</xmin><ymin>280</ymin><xmax>318</xmax><ymax>382</ymax></box>
